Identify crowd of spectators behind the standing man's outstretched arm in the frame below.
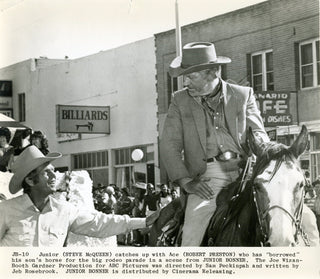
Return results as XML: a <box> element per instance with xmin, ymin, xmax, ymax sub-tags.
<box><xmin>92</xmin><ymin>183</ymin><xmax>179</xmax><ymax>246</ymax></box>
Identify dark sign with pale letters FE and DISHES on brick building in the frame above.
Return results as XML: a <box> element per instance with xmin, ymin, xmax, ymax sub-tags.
<box><xmin>255</xmin><ymin>92</ymin><xmax>292</xmax><ymax>127</ymax></box>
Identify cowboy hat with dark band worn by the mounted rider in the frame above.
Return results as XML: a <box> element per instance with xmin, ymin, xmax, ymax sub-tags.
<box><xmin>169</xmin><ymin>42</ymin><xmax>231</xmax><ymax>77</ymax></box>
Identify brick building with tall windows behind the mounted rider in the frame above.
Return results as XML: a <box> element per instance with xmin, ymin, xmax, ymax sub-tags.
<box><xmin>155</xmin><ymin>0</ymin><xmax>320</xmax><ymax>181</ymax></box>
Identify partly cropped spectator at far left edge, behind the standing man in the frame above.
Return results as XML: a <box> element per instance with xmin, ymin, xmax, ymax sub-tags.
<box><xmin>0</xmin><ymin>127</ymin><xmax>14</xmax><ymax>172</ymax></box>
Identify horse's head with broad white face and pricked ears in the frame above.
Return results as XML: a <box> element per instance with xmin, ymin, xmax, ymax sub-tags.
<box><xmin>248</xmin><ymin>126</ymin><xmax>308</xmax><ymax>246</ymax></box>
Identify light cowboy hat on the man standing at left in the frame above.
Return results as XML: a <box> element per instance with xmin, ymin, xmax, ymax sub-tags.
<box><xmin>9</xmin><ymin>145</ymin><xmax>61</xmax><ymax>194</ymax></box>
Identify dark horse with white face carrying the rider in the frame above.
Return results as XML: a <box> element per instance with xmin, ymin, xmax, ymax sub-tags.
<box><xmin>150</xmin><ymin>126</ymin><xmax>308</xmax><ymax>247</ymax></box>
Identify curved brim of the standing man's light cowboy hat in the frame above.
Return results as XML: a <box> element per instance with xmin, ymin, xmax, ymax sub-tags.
<box><xmin>9</xmin><ymin>152</ymin><xmax>62</xmax><ymax>194</ymax></box>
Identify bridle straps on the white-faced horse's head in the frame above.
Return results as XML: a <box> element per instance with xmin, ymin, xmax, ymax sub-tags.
<box><xmin>252</xmin><ymin>155</ymin><xmax>310</xmax><ymax>246</ymax></box>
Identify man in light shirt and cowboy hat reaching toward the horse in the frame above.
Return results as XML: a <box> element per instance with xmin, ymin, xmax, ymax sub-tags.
<box><xmin>0</xmin><ymin>146</ymin><xmax>157</xmax><ymax>247</ymax></box>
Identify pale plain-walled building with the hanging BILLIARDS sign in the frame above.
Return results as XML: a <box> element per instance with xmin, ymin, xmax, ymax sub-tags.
<box><xmin>0</xmin><ymin>38</ymin><xmax>160</xmax><ymax>190</ymax></box>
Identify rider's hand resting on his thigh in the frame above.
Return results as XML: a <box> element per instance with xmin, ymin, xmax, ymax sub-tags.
<box><xmin>181</xmin><ymin>178</ymin><xmax>214</xmax><ymax>200</ymax></box>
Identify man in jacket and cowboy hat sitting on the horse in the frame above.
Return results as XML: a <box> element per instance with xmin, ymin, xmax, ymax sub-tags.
<box><xmin>160</xmin><ymin>42</ymin><xmax>269</xmax><ymax>246</ymax></box>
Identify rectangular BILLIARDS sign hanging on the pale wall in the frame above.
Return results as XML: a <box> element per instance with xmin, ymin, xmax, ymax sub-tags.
<box><xmin>57</xmin><ymin>105</ymin><xmax>110</xmax><ymax>134</ymax></box>
